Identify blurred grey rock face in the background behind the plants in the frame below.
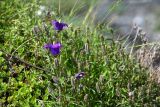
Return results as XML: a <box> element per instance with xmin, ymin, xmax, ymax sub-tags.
<box><xmin>97</xmin><ymin>0</ymin><xmax>160</xmax><ymax>41</ymax></box>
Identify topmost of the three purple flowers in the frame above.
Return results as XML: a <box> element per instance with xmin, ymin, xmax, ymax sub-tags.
<box><xmin>52</xmin><ymin>20</ymin><xmax>68</xmax><ymax>31</ymax></box>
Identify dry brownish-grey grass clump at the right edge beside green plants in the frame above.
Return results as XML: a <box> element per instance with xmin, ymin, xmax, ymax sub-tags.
<box><xmin>130</xmin><ymin>26</ymin><xmax>160</xmax><ymax>84</ymax></box>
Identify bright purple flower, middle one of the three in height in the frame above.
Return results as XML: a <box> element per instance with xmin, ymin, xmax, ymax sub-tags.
<box><xmin>44</xmin><ymin>42</ymin><xmax>62</xmax><ymax>56</ymax></box>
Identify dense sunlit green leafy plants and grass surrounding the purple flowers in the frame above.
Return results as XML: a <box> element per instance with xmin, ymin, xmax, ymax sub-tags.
<box><xmin>0</xmin><ymin>0</ymin><xmax>160</xmax><ymax>107</ymax></box>
